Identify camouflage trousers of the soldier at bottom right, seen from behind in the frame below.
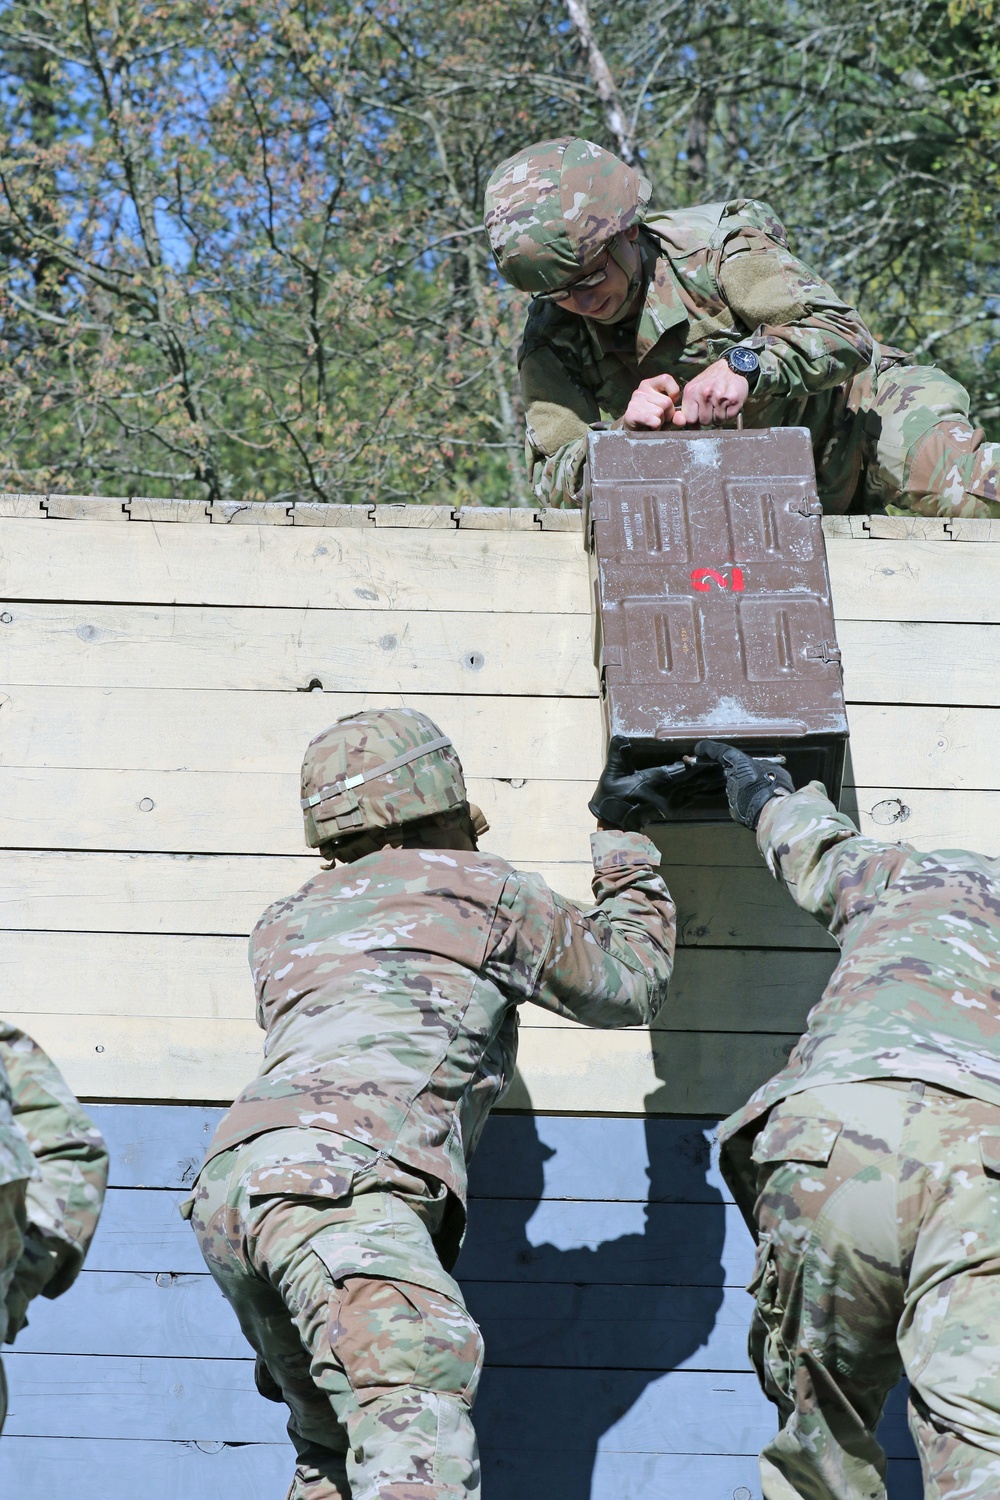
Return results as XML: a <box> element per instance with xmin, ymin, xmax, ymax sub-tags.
<box><xmin>723</xmin><ymin>1080</ymin><xmax>1000</xmax><ymax>1500</ymax></box>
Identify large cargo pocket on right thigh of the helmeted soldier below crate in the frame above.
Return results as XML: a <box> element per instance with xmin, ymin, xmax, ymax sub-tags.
<box><xmin>312</xmin><ymin>1235</ymin><xmax>483</xmax><ymax>1406</ymax></box>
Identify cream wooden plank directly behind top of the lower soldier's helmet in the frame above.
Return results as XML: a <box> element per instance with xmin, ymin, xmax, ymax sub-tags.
<box><xmin>7</xmin><ymin>687</ymin><xmax>1000</xmax><ymax>798</ymax></box>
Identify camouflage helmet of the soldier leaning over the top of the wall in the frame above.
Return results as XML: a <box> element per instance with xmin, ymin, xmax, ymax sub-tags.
<box><xmin>483</xmin><ymin>135</ymin><xmax>652</xmax><ymax>293</ymax></box>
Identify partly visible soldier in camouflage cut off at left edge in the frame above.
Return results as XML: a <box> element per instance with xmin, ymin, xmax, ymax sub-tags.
<box><xmin>0</xmin><ymin>1022</ymin><xmax>108</xmax><ymax>1428</ymax></box>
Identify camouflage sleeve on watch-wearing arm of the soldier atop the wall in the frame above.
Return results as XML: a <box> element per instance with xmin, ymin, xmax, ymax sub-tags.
<box><xmin>717</xmin><ymin>228</ymin><xmax>876</xmax><ymax>407</ymax></box>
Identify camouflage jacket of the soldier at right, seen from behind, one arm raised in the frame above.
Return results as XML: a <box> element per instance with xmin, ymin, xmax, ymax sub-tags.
<box><xmin>720</xmin><ymin>782</ymin><xmax>1000</xmax><ymax>1140</ymax></box>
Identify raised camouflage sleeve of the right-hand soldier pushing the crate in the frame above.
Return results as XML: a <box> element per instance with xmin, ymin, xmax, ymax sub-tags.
<box><xmin>757</xmin><ymin>782</ymin><xmax>913</xmax><ymax>939</ymax></box>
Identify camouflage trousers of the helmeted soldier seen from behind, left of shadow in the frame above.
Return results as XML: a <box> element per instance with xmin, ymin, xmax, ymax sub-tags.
<box><xmin>192</xmin><ymin>1130</ymin><xmax>483</xmax><ymax>1500</ymax></box>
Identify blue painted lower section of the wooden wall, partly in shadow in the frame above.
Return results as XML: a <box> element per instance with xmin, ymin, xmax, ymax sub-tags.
<box><xmin>0</xmin><ymin>1106</ymin><xmax>921</xmax><ymax>1500</ymax></box>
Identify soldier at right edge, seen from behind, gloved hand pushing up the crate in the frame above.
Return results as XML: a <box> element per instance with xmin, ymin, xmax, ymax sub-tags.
<box><xmin>696</xmin><ymin>741</ymin><xmax>1000</xmax><ymax>1500</ymax></box>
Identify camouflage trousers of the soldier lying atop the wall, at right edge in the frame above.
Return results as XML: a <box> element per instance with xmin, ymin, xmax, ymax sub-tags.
<box><xmin>850</xmin><ymin>365</ymin><xmax>1000</xmax><ymax>516</ymax></box>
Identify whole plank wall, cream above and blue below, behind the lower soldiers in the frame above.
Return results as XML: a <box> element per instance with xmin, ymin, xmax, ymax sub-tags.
<box><xmin>0</xmin><ymin>497</ymin><xmax>1000</xmax><ymax>1500</ymax></box>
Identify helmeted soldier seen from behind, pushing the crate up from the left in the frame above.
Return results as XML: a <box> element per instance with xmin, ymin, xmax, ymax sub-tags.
<box><xmin>184</xmin><ymin>708</ymin><xmax>673</xmax><ymax>1500</ymax></box>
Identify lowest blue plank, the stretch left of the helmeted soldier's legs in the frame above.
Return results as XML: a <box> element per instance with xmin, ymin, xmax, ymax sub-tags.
<box><xmin>0</xmin><ymin>1436</ymin><xmax>295</xmax><ymax>1500</ymax></box>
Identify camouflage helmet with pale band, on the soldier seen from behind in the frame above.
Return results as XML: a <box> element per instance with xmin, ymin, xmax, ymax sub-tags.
<box><xmin>301</xmin><ymin>708</ymin><xmax>466</xmax><ymax>849</ymax></box>
